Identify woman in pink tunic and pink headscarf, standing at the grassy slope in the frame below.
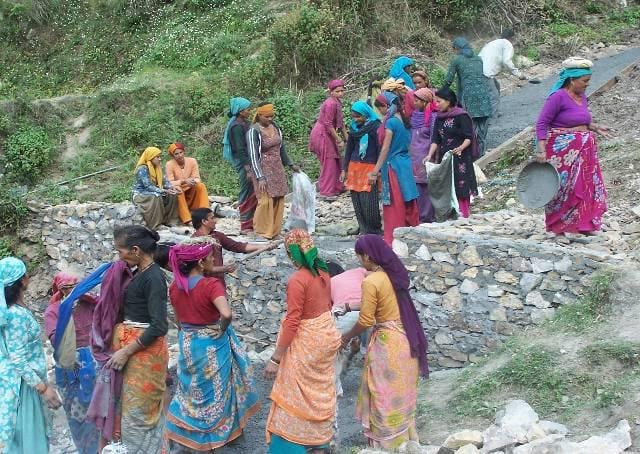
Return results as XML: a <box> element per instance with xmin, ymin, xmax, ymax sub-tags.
<box><xmin>309</xmin><ymin>80</ymin><xmax>347</xmax><ymax>197</ymax></box>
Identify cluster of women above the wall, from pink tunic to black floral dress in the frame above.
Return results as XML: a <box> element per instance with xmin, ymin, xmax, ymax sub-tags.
<box><xmin>316</xmin><ymin>56</ymin><xmax>482</xmax><ymax>244</ymax></box>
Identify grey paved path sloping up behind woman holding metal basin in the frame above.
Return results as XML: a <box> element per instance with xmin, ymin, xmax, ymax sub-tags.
<box><xmin>487</xmin><ymin>47</ymin><xmax>640</xmax><ymax>149</ymax></box>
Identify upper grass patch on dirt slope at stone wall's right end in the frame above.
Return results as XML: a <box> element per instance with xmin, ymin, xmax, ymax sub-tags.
<box><xmin>548</xmin><ymin>270</ymin><xmax>615</xmax><ymax>333</ymax></box>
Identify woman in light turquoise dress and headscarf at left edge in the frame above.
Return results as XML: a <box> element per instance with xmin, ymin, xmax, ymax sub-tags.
<box><xmin>0</xmin><ymin>257</ymin><xmax>61</xmax><ymax>454</ymax></box>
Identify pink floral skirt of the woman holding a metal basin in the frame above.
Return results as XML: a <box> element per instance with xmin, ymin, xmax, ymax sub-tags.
<box><xmin>545</xmin><ymin>130</ymin><xmax>607</xmax><ymax>233</ymax></box>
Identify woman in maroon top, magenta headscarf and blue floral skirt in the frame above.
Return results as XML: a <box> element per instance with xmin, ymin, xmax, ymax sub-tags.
<box><xmin>165</xmin><ymin>243</ymin><xmax>260</xmax><ymax>454</ymax></box>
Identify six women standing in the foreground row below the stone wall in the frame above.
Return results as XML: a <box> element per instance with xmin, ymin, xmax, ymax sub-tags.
<box><xmin>0</xmin><ymin>226</ymin><xmax>428</xmax><ymax>454</ymax></box>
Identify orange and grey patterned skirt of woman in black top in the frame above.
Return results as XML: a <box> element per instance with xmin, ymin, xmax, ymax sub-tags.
<box><xmin>112</xmin><ymin>322</ymin><xmax>169</xmax><ymax>454</ymax></box>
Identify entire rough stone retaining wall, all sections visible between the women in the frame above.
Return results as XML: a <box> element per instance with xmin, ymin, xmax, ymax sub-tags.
<box><xmin>21</xmin><ymin>203</ymin><xmax>627</xmax><ymax>368</ymax></box>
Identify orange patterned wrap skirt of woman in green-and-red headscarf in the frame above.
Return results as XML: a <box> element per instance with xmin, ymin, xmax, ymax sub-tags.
<box><xmin>267</xmin><ymin>312</ymin><xmax>340</xmax><ymax>446</ymax></box>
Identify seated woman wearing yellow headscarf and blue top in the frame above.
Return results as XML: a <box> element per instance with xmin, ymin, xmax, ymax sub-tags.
<box><xmin>133</xmin><ymin>147</ymin><xmax>179</xmax><ymax>230</ymax></box>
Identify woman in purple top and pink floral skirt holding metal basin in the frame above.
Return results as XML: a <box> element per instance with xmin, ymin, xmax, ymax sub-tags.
<box><xmin>536</xmin><ymin>57</ymin><xmax>609</xmax><ymax>234</ymax></box>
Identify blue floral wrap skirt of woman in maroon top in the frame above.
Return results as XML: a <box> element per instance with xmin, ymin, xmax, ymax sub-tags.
<box><xmin>166</xmin><ymin>323</ymin><xmax>260</xmax><ymax>452</ymax></box>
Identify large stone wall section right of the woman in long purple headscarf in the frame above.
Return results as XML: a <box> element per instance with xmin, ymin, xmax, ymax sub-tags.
<box><xmin>394</xmin><ymin>212</ymin><xmax>627</xmax><ymax>368</ymax></box>
